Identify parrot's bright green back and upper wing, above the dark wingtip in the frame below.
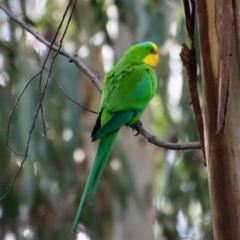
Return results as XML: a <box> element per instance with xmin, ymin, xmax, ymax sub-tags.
<box><xmin>101</xmin><ymin>66</ymin><xmax>157</xmax><ymax>112</ymax></box>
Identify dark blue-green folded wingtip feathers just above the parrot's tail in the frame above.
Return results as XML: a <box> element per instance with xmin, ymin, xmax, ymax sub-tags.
<box><xmin>92</xmin><ymin>111</ymin><xmax>134</xmax><ymax>141</ymax></box>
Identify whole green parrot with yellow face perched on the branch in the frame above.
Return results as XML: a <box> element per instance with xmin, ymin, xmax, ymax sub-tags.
<box><xmin>72</xmin><ymin>42</ymin><xmax>159</xmax><ymax>231</ymax></box>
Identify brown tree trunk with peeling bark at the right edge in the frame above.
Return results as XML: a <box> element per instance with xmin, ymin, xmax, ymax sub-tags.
<box><xmin>196</xmin><ymin>0</ymin><xmax>240</xmax><ymax>240</ymax></box>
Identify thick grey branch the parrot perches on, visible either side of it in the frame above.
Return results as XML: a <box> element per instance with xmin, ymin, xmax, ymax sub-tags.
<box><xmin>0</xmin><ymin>3</ymin><xmax>201</xmax><ymax>150</ymax></box>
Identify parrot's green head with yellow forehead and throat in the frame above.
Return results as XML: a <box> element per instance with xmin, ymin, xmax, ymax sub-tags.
<box><xmin>126</xmin><ymin>42</ymin><xmax>159</xmax><ymax>68</ymax></box>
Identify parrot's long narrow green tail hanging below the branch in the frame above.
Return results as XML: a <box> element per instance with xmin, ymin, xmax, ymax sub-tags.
<box><xmin>72</xmin><ymin>129</ymin><xmax>119</xmax><ymax>232</ymax></box>
